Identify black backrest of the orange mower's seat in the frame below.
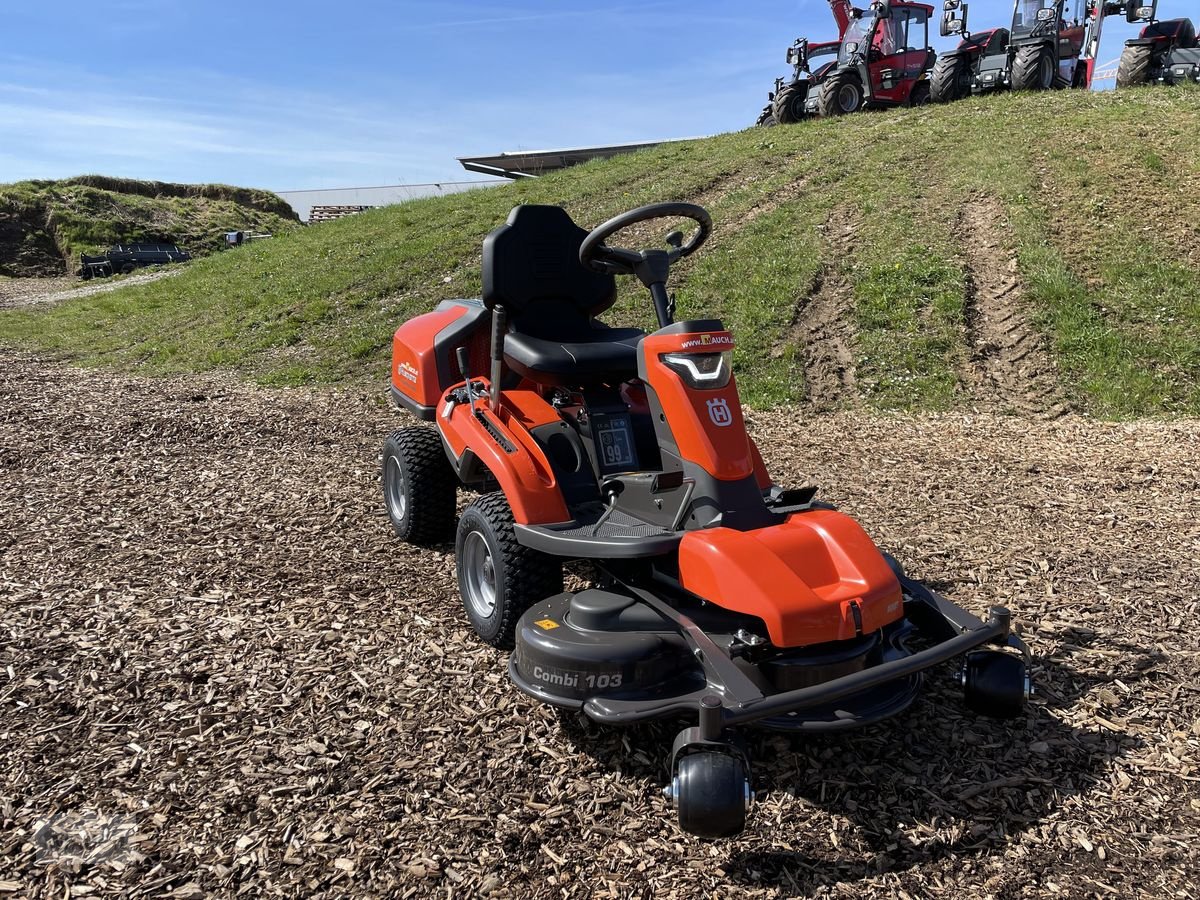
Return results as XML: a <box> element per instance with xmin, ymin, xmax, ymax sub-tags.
<box><xmin>482</xmin><ymin>205</ymin><xmax>617</xmax><ymax>336</ymax></box>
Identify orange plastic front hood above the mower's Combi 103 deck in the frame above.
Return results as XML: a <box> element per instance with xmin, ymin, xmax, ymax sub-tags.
<box><xmin>679</xmin><ymin>509</ymin><xmax>904</xmax><ymax>647</ymax></box>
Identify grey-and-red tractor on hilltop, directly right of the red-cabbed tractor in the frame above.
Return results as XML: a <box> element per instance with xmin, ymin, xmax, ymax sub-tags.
<box><xmin>930</xmin><ymin>0</ymin><xmax>1137</xmax><ymax>103</ymax></box>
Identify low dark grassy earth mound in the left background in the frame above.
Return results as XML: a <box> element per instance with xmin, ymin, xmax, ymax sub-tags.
<box><xmin>0</xmin><ymin>175</ymin><xmax>299</xmax><ymax>276</ymax></box>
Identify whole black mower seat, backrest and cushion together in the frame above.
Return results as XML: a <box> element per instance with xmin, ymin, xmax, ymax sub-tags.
<box><xmin>482</xmin><ymin>204</ymin><xmax>644</xmax><ymax>386</ymax></box>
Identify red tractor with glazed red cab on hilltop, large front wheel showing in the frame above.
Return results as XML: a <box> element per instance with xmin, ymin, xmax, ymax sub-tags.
<box><xmin>804</xmin><ymin>0</ymin><xmax>936</xmax><ymax>116</ymax></box>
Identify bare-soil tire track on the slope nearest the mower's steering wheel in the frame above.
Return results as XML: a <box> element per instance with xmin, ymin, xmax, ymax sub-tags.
<box><xmin>770</xmin><ymin>206</ymin><xmax>858</xmax><ymax>409</ymax></box>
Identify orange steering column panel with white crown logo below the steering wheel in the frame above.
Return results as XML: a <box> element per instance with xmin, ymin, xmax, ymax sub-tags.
<box><xmin>642</xmin><ymin>331</ymin><xmax>766</xmax><ymax>481</ymax></box>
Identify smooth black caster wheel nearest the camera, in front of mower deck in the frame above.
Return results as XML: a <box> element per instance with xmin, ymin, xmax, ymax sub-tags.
<box><xmin>674</xmin><ymin>751</ymin><xmax>746</xmax><ymax>839</ymax></box>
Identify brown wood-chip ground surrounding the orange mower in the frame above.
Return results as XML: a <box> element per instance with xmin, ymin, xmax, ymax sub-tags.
<box><xmin>0</xmin><ymin>353</ymin><xmax>1200</xmax><ymax>898</ymax></box>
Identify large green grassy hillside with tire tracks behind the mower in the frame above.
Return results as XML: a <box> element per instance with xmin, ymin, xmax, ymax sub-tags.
<box><xmin>0</xmin><ymin>89</ymin><xmax>1200</xmax><ymax>416</ymax></box>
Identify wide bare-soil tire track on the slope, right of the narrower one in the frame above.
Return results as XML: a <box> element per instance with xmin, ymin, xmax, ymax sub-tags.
<box><xmin>960</xmin><ymin>198</ymin><xmax>1069</xmax><ymax>419</ymax></box>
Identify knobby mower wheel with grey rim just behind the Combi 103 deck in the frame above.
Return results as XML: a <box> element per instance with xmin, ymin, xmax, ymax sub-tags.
<box><xmin>455</xmin><ymin>492</ymin><xmax>563</xmax><ymax>650</ymax></box>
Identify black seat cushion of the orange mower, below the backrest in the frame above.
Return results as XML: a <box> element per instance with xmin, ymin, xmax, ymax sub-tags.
<box><xmin>504</xmin><ymin>322</ymin><xmax>646</xmax><ymax>385</ymax></box>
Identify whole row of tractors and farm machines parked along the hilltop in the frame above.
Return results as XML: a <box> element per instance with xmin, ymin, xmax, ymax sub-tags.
<box><xmin>757</xmin><ymin>0</ymin><xmax>1200</xmax><ymax>126</ymax></box>
